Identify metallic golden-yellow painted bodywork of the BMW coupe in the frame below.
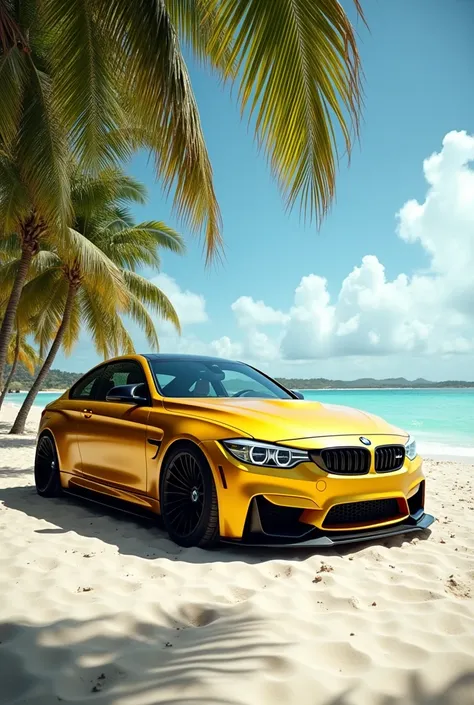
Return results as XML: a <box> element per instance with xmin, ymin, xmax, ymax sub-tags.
<box><xmin>39</xmin><ymin>355</ymin><xmax>432</xmax><ymax>538</ymax></box>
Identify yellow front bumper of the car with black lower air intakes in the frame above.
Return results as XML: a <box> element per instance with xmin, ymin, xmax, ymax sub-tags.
<box><xmin>201</xmin><ymin>437</ymin><xmax>434</xmax><ymax>546</ymax></box>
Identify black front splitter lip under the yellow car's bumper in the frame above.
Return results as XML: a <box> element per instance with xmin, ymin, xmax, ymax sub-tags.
<box><xmin>221</xmin><ymin>510</ymin><xmax>435</xmax><ymax>548</ymax></box>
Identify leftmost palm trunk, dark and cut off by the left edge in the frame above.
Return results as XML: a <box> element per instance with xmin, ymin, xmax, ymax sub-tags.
<box><xmin>0</xmin><ymin>212</ymin><xmax>46</xmax><ymax>389</ymax></box>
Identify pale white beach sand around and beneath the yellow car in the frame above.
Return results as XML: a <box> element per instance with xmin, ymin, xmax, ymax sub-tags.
<box><xmin>0</xmin><ymin>407</ymin><xmax>474</xmax><ymax>705</ymax></box>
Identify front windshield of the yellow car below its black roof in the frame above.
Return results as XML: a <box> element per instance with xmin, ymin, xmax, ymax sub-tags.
<box><xmin>149</xmin><ymin>358</ymin><xmax>293</xmax><ymax>399</ymax></box>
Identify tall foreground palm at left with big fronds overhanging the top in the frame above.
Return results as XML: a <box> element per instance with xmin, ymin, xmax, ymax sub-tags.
<box><xmin>0</xmin><ymin>0</ymin><xmax>363</xmax><ymax>382</ymax></box>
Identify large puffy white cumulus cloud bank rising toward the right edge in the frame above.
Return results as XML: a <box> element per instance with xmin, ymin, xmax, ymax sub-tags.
<box><xmin>218</xmin><ymin>132</ymin><xmax>474</xmax><ymax>361</ymax></box>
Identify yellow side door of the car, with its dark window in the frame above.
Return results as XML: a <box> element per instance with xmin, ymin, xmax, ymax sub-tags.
<box><xmin>77</xmin><ymin>360</ymin><xmax>151</xmax><ymax>492</ymax></box>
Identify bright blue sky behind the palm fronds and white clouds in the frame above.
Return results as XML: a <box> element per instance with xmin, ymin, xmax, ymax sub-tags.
<box><xmin>55</xmin><ymin>0</ymin><xmax>474</xmax><ymax>379</ymax></box>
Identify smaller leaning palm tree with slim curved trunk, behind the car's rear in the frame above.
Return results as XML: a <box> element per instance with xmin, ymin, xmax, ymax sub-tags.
<box><xmin>10</xmin><ymin>169</ymin><xmax>184</xmax><ymax>433</ymax></box>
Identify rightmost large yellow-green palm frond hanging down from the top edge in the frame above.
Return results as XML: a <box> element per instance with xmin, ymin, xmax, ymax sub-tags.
<box><xmin>207</xmin><ymin>0</ymin><xmax>363</xmax><ymax>220</ymax></box>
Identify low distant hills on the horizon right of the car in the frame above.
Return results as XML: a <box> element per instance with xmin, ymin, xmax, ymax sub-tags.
<box><xmin>278</xmin><ymin>377</ymin><xmax>474</xmax><ymax>389</ymax></box>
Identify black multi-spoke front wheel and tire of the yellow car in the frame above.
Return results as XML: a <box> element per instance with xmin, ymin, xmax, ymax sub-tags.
<box><xmin>160</xmin><ymin>444</ymin><xmax>220</xmax><ymax>549</ymax></box>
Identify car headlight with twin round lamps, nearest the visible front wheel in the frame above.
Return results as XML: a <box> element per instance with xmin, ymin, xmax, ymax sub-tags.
<box><xmin>221</xmin><ymin>438</ymin><xmax>310</xmax><ymax>468</ymax></box>
